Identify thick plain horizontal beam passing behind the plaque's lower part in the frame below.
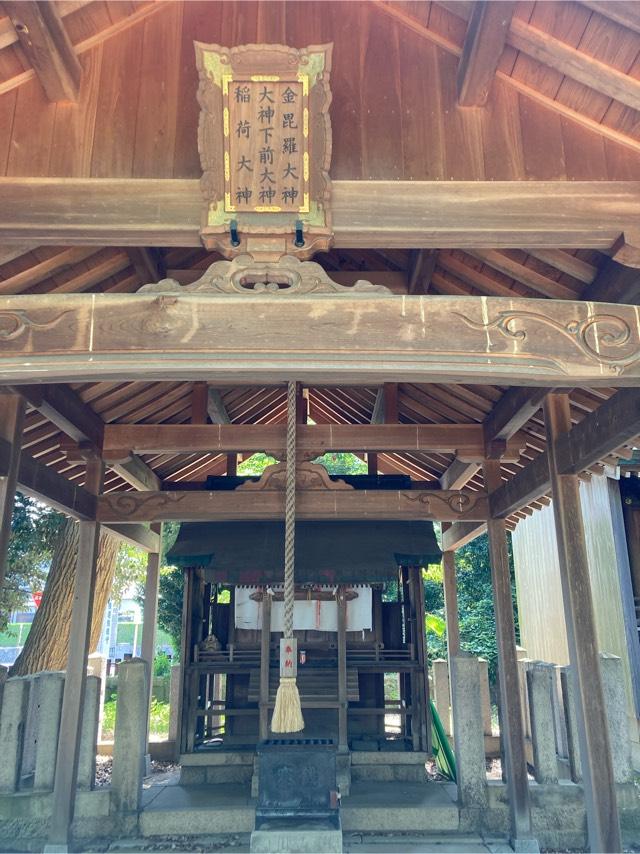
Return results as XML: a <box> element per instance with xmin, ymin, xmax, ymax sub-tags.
<box><xmin>0</xmin><ymin>178</ymin><xmax>640</xmax><ymax>250</ymax></box>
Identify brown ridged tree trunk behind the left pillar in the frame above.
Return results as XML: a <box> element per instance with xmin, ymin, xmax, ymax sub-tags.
<box><xmin>10</xmin><ymin>519</ymin><xmax>120</xmax><ymax>676</ymax></box>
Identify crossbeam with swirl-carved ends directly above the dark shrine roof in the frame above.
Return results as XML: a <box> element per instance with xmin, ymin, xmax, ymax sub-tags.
<box><xmin>98</xmin><ymin>489</ymin><xmax>488</xmax><ymax>524</ymax></box>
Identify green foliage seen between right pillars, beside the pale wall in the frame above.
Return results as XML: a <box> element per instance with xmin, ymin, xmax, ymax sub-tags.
<box><xmin>423</xmin><ymin>534</ymin><xmax>518</xmax><ymax>684</ymax></box>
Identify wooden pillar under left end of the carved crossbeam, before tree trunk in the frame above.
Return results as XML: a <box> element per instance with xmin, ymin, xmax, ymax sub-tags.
<box><xmin>49</xmin><ymin>460</ymin><xmax>104</xmax><ymax>846</ymax></box>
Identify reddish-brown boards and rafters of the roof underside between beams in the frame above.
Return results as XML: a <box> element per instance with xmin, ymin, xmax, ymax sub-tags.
<box><xmin>0</xmin><ymin>2</ymin><xmax>640</xmax><ymax>521</ymax></box>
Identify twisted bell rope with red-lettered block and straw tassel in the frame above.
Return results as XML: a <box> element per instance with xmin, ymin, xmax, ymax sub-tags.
<box><xmin>271</xmin><ymin>382</ymin><xmax>304</xmax><ymax>732</ymax></box>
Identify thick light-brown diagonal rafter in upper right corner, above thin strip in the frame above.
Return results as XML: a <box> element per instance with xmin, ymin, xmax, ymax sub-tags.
<box><xmin>507</xmin><ymin>18</ymin><xmax>640</xmax><ymax>110</ymax></box>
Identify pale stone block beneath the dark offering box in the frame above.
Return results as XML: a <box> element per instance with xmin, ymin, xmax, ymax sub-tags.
<box><xmin>250</xmin><ymin>820</ymin><xmax>342</xmax><ymax>854</ymax></box>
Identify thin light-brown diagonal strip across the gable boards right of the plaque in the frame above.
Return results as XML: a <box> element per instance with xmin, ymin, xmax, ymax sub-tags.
<box><xmin>373</xmin><ymin>0</ymin><xmax>640</xmax><ymax>155</ymax></box>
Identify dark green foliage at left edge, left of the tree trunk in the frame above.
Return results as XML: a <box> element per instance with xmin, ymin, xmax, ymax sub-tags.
<box><xmin>0</xmin><ymin>492</ymin><xmax>65</xmax><ymax>631</ymax></box>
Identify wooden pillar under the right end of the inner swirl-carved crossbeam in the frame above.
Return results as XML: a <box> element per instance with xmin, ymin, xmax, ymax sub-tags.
<box><xmin>484</xmin><ymin>460</ymin><xmax>532</xmax><ymax>840</ymax></box>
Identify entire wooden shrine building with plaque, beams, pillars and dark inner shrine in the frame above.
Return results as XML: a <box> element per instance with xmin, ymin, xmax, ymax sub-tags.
<box><xmin>0</xmin><ymin>0</ymin><xmax>640</xmax><ymax>851</ymax></box>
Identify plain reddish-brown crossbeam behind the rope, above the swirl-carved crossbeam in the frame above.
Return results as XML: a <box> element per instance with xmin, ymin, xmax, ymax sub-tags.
<box><xmin>103</xmin><ymin>424</ymin><xmax>522</xmax><ymax>462</ymax></box>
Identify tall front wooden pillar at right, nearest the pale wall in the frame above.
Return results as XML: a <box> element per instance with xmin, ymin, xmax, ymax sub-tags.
<box><xmin>544</xmin><ymin>394</ymin><xmax>622</xmax><ymax>852</ymax></box>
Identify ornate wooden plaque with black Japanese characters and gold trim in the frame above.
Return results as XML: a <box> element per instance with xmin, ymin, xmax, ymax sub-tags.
<box><xmin>195</xmin><ymin>42</ymin><xmax>331</xmax><ymax>259</ymax></box>
